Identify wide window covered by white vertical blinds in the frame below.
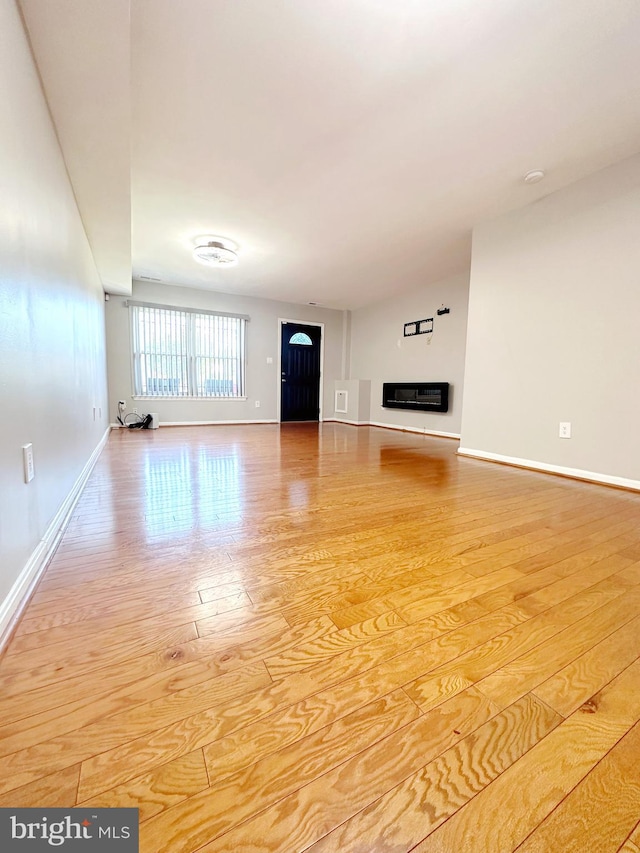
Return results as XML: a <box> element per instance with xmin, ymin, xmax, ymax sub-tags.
<box><xmin>129</xmin><ymin>303</ymin><xmax>246</xmax><ymax>397</ymax></box>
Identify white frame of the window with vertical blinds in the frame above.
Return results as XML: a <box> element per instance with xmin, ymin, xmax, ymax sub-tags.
<box><xmin>125</xmin><ymin>299</ymin><xmax>250</xmax><ymax>402</ymax></box>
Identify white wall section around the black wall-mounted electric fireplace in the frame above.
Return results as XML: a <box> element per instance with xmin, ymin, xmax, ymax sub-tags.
<box><xmin>350</xmin><ymin>275</ymin><xmax>469</xmax><ymax>435</ymax></box>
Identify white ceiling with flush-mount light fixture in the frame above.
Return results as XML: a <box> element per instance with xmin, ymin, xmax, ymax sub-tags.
<box><xmin>21</xmin><ymin>0</ymin><xmax>640</xmax><ymax>308</ymax></box>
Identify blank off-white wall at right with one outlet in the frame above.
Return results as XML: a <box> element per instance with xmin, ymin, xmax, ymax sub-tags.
<box><xmin>461</xmin><ymin>157</ymin><xmax>640</xmax><ymax>481</ymax></box>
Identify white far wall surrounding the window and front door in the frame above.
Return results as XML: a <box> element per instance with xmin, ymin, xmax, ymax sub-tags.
<box><xmin>107</xmin><ymin>281</ymin><xmax>344</xmax><ymax>423</ymax></box>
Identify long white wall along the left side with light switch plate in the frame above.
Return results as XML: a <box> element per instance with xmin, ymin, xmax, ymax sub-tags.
<box><xmin>0</xmin><ymin>0</ymin><xmax>108</xmax><ymax>635</ymax></box>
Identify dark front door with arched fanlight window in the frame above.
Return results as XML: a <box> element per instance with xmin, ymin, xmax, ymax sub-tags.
<box><xmin>280</xmin><ymin>323</ymin><xmax>321</xmax><ymax>421</ymax></box>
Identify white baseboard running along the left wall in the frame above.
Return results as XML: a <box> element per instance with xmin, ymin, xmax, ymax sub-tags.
<box><xmin>0</xmin><ymin>427</ymin><xmax>111</xmax><ymax>651</ymax></box>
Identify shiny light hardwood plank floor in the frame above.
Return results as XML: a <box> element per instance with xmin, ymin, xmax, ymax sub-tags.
<box><xmin>0</xmin><ymin>424</ymin><xmax>640</xmax><ymax>853</ymax></box>
